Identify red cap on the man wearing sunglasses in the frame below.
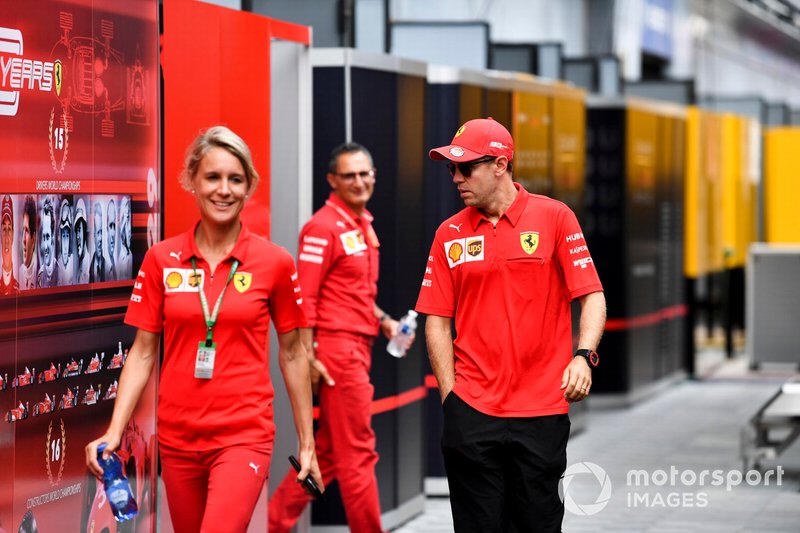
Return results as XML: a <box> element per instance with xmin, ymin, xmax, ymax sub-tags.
<box><xmin>428</xmin><ymin>117</ymin><xmax>514</xmax><ymax>161</ymax></box>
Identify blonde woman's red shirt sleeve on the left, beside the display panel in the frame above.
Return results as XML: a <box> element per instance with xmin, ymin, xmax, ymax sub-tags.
<box><xmin>125</xmin><ymin>248</ymin><xmax>164</xmax><ymax>333</ymax></box>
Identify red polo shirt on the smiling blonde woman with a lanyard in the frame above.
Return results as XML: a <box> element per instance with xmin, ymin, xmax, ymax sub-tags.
<box><xmin>125</xmin><ymin>222</ymin><xmax>307</xmax><ymax>451</ymax></box>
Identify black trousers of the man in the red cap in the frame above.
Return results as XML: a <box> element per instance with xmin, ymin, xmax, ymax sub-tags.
<box><xmin>442</xmin><ymin>392</ymin><xmax>570</xmax><ymax>533</ymax></box>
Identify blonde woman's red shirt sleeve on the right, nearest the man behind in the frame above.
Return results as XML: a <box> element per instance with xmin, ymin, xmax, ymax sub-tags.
<box><xmin>269</xmin><ymin>249</ymin><xmax>308</xmax><ymax>333</ymax></box>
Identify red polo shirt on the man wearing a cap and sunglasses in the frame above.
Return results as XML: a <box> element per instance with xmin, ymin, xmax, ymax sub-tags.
<box><xmin>416</xmin><ymin>183</ymin><xmax>603</xmax><ymax>417</ymax></box>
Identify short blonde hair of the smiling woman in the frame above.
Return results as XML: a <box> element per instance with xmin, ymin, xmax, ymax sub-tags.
<box><xmin>179</xmin><ymin>126</ymin><xmax>258</xmax><ymax>193</ymax></box>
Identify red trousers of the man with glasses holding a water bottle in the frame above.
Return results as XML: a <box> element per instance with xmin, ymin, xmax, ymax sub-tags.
<box><xmin>269</xmin><ymin>331</ymin><xmax>383</xmax><ymax>533</ymax></box>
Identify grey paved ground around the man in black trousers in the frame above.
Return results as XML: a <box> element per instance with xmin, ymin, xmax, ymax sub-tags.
<box><xmin>394</xmin><ymin>357</ymin><xmax>800</xmax><ymax>533</ymax></box>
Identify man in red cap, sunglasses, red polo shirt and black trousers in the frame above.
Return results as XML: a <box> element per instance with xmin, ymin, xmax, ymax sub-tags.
<box><xmin>416</xmin><ymin>118</ymin><xmax>605</xmax><ymax>533</ymax></box>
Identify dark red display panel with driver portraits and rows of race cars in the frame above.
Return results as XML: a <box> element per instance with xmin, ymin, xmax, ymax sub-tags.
<box><xmin>0</xmin><ymin>0</ymin><xmax>160</xmax><ymax>531</ymax></box>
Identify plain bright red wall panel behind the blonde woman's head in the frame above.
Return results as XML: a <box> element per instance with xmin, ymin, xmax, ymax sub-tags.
<box><xmin>161</xmin><ymin>0</ymin><xmax>276</xmax><ymax>237</ymax></box>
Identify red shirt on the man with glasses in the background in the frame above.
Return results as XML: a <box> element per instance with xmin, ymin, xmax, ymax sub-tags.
<box><xmin>297</xmin><ymin>193</ymin><xmax>380</xmax><ymax>336</ymax></box>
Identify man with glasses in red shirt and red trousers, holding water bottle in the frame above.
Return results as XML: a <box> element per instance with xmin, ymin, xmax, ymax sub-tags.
<box><xmin>269</xmin><ymin>143</ymin><xmax>406</xmax><ymax>533</ymax></box>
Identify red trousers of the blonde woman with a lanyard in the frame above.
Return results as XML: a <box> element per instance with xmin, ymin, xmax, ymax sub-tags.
<box><xmin>160</xmin><ymin>442</ymin><xmax>272</xmax><ymax>533</ymax></box>
